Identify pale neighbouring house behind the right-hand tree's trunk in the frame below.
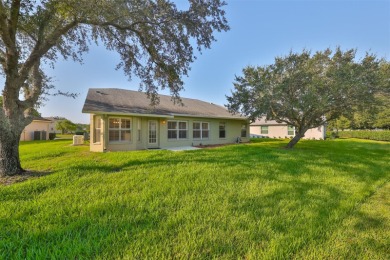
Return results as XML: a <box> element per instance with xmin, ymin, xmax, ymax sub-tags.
<box><xmin>250</xmin><ymin>118</ymin><xmax>326</xmax><ymax>140</ymax></box>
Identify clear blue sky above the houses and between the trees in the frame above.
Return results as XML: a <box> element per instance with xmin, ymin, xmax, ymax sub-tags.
<box><xmin>3</xmin><ymin>0</ymin><xmax>390</xmax><ymax>123</ymax></box>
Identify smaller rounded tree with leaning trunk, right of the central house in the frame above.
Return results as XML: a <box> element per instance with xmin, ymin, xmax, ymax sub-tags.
<box><xmin>227</xmin><ymin>48</ymin><xmax>389</xmax><ymax>148</ymax></box>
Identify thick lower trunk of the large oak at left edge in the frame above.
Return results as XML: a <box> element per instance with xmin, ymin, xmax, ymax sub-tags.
<box><xmin>0</xmin><ymin>129</ymin><xmax>24</xmax><ymax>177</ymax></box>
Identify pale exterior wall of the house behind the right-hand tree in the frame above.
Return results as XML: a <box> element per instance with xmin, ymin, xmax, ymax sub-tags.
<box><xmin>250</xmin><ymin>125</ymin><xmax>325</xmax><ymax>139</ymax></box>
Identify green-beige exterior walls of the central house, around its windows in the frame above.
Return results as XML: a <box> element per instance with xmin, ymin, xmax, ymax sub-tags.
<box><xmin>90</xmin><ymin>114</ymin><xmax>249</xmax><ymax>152</ymax></box>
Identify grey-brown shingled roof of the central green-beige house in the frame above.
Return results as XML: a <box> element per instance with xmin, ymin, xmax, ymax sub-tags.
<box><xmin>82</xmin><ymin>88</ymin><xmax>246</xmax><ymax>120</ymax></box>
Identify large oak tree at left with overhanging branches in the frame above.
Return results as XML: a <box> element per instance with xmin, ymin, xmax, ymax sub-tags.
<box><xmin>0</xmin><ymin>0</ymin><xmax>229</xmax><ymax>175</ymax></box>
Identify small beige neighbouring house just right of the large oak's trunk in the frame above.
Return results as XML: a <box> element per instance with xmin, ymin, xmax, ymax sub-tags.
<box><xmin>20</xmin><ymin>117</ymin><xmax>50</xmax><ymax>141</ymax></box>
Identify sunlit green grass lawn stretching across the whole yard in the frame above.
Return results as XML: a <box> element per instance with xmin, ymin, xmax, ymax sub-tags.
<box><xmin>0</xmin><ymin>139</ymin><xmax>390</xmax><ymax>259</ymax></box>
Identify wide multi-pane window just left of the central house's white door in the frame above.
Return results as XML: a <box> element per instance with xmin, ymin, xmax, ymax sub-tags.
<box><xmin>108</xmin><ymin>118</ymin><xmax>131</xmax><ymax>142</ymax></box>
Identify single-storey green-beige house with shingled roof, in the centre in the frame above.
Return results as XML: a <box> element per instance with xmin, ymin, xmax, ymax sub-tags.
<box><xmin>82</xmin><ymin>88</ymin><xmax>249</xmax><ymax>152</ymax></box>
